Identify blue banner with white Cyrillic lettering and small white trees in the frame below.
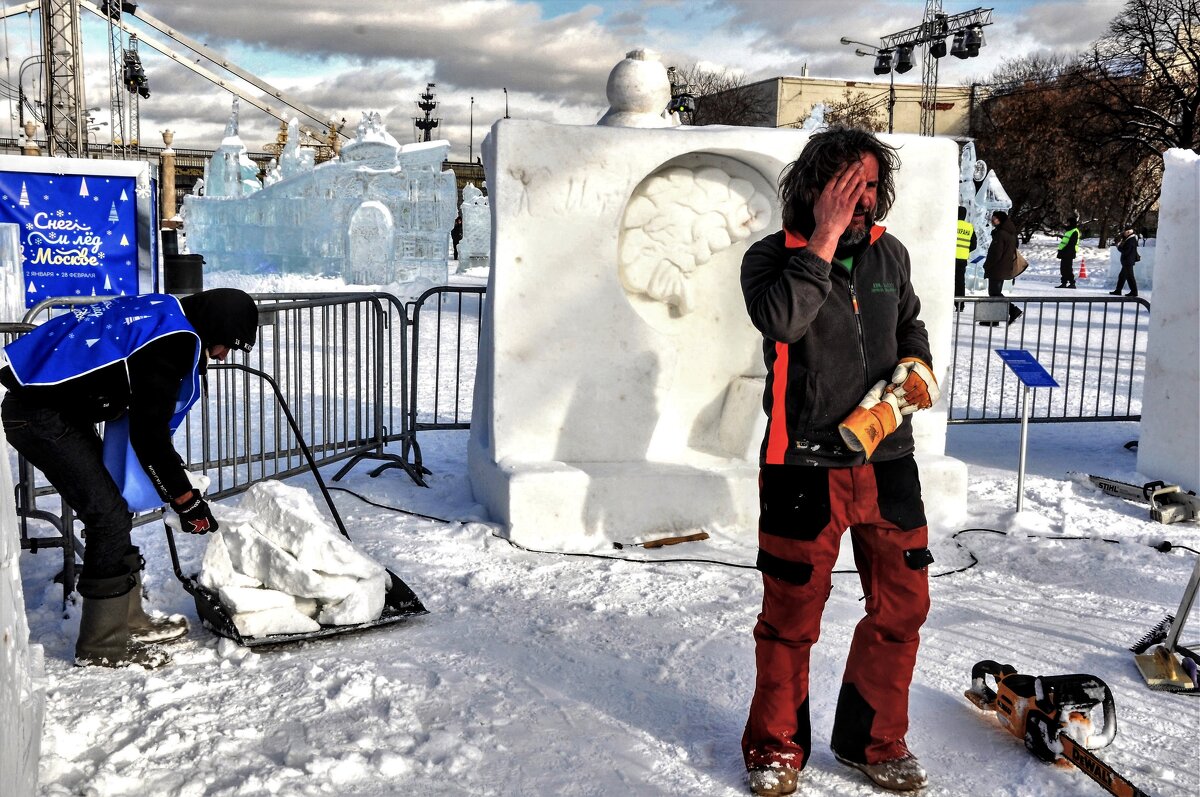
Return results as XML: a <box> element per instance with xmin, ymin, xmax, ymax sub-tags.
<box><xmin>0</xmin><ymin>172</ymin><xmax>138</xmax><ymax>307</ymax></box>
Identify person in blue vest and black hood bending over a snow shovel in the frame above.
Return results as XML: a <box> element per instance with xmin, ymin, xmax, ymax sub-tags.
<box><xmin>0</xmin><ymin>288</ymin><xmax>258</xmax><ymax>669</ymax></box>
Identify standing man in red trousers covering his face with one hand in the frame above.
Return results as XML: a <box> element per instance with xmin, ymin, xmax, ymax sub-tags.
<box><xmin>742</xmin><ymin>127</ymin><xmax>938</xmax><ymax>796</ymax></box>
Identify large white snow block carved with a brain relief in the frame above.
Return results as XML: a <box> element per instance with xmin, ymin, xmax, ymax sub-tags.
<box><xmin>468</xmin><ymin>119</ymin><xmax>966</xmax><ymax>550</ymax></box>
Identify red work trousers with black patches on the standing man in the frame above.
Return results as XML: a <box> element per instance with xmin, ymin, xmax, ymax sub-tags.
<box><xmin>742</xmin><ymin>456</ymin><xmax>932</xmax><ymax>769</ymax></box>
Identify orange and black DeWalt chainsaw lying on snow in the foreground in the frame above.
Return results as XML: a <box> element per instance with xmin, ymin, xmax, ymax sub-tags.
<box><xmin>965</xmin><ymin>660</ymin><xmax>1148</xmax><ymax>797</ymax></box>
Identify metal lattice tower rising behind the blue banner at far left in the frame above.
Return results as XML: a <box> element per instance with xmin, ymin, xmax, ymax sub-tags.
<box><xmin>41</xmin><ymin>0</ymin><xmax>88</xmax><ymax>157</ymax></box>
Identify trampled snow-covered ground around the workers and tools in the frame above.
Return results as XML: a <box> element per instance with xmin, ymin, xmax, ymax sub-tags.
<box><xmin>22</xmin><ymin>239</ymin><xmax>1200</xmax><ymax>797</ymax></box>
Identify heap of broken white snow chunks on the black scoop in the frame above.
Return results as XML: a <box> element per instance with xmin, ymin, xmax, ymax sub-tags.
<box><xmin>199</xmin><ymin>481</ymin><xmax>390</xmax><ymax>636</ymax></box>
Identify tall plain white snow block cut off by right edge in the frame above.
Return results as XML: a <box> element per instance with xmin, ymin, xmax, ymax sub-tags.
<box><xmin>1138</xmin><ymin>149</ymin><xmax>1200</xmax><ymax>490</ymax></box>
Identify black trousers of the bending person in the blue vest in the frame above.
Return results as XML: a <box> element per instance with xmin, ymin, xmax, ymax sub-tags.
<box><xmin>0</xmin><ymin>392</ymin><xmax>133</xmax><ymax>579</ymax></box>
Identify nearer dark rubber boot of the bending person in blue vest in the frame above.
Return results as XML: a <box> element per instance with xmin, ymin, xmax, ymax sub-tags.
<box><xmin>76</xmin><ymin>573</ymin><xmax>170</xmax><ymax>670</ymax></box>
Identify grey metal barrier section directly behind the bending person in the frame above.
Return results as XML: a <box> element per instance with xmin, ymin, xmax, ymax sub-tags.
<box><xmin>0</xmin><ymin>293</ymin><xmax>408</xmax><ymax>582</ymax></box>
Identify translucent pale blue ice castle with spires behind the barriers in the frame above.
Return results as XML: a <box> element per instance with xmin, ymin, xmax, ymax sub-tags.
<box><xmin>182</xmin><ymin>109</ymin><xmax>457</xmax><ymax>295</ymax></box>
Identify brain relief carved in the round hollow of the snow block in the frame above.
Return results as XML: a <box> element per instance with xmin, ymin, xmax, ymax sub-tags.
<box><xmin>619</xmin><ymin>166</ymin><xmax>772</xmax><ymax>314</ymax></box>
